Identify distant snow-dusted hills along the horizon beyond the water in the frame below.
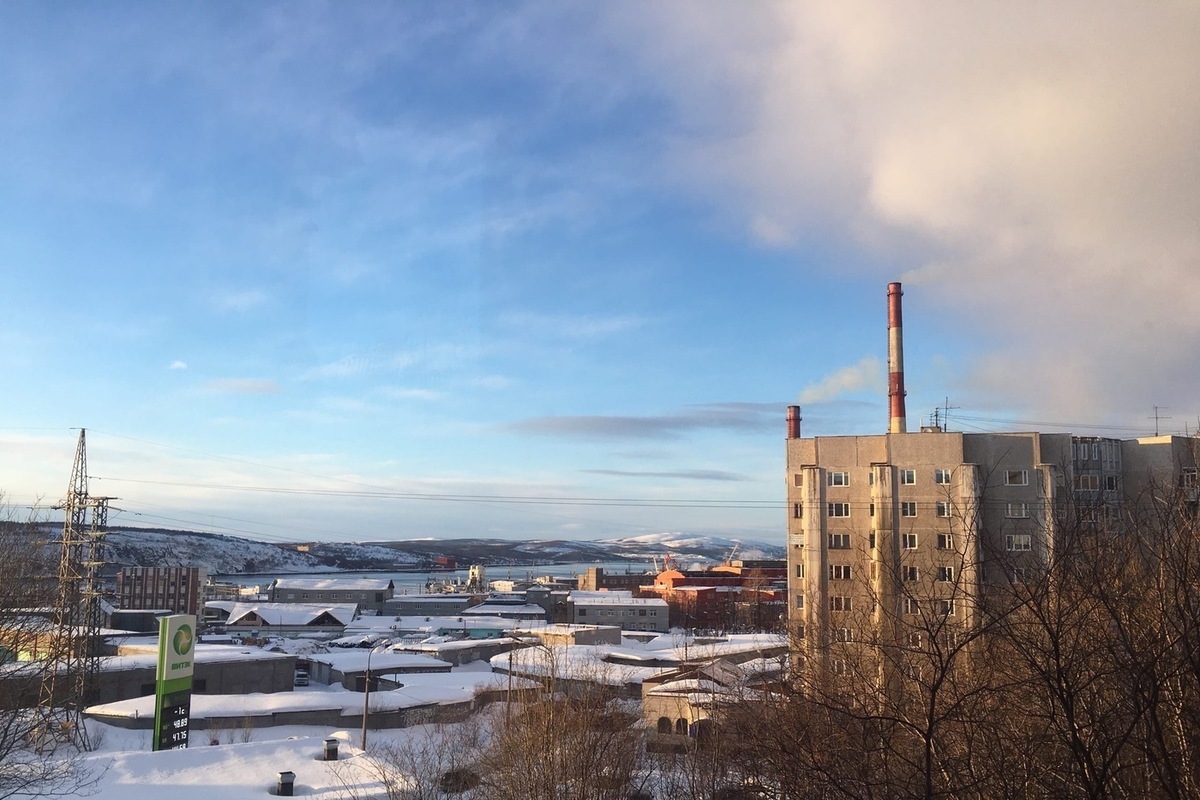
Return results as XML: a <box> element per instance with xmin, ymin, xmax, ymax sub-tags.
<box><xmin>104</xmin><ymin>528</ymin><xmax>784</xmax><ymax>575</ymax></box>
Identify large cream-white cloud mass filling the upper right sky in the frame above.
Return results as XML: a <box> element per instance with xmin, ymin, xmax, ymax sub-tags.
<box><xmin>610</xmin><ymin>0</ymin><xmax>1200</xmax><ymax>413</ymax></box>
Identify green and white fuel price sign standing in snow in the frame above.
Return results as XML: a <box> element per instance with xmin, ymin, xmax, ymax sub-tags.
<box><xmin>154</xmin><ymin>614</ymin><xmax>196</xmax><ymax>750</ymax></box>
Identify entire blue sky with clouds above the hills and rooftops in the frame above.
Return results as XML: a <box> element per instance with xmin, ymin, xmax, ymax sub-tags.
<box><xmin>0</xmin><ymin>0</ymin><xmax>1200</xmax><ymax>542</ymax></box>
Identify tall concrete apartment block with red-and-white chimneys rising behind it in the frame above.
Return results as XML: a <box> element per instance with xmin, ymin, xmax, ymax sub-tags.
<box><xmin>786</xmin><ymin>284</ymin><xmax>1200</xmax><ymax>674</ymax></box>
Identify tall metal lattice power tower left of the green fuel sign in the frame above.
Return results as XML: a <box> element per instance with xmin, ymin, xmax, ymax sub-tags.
<box><xmin>36</xmin><ymin>429</ymin><xmax>114</xmax><ymax>751</ymax></box>
